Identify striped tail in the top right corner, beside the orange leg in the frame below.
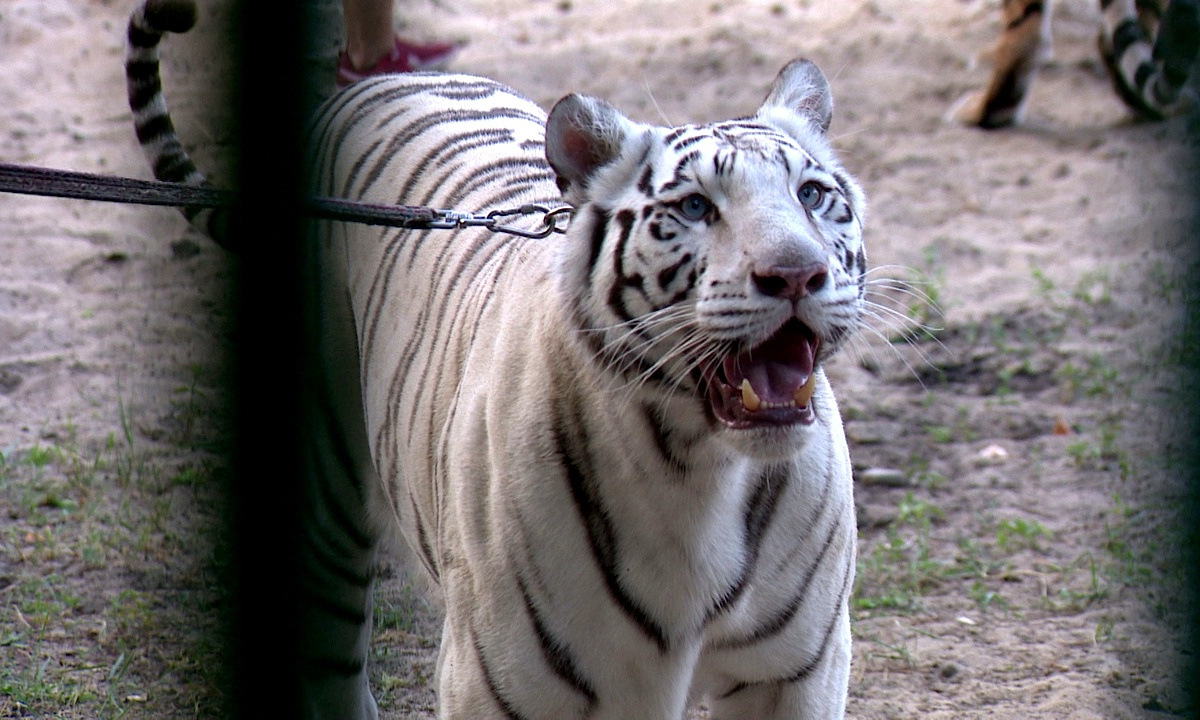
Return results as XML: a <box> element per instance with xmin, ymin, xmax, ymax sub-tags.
<box><xmin>1099</xmin><ymin>0</ymin><xmax>1200</xmax><ymax>120</ymax></box>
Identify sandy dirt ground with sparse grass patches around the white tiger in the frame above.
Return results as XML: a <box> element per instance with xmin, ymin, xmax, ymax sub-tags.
<box><xmin>0</xmin><ymin>0</ymin><xmax>1200</xmax><ymax>720</ymax></box>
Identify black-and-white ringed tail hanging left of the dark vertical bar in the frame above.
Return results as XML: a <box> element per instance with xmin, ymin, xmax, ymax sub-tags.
<box><xmin>125</xmin><ymin>0</ymin><xmax>233</xmax><ymax>250</ymax></box>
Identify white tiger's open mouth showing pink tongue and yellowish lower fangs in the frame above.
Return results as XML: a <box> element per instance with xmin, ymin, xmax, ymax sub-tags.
<box><xmin>707</xmin><ymin>318</ymin><xmax>821</xmax><ymax>430</ymax></box>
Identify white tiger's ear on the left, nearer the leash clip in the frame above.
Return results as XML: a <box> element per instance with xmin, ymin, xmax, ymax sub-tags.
<box><xmin>546</xmin><ymin>95</ymin><xmax>631</xmax><ymax>194</ymax></box>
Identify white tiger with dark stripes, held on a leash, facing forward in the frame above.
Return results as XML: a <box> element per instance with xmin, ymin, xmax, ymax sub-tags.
<box><xmin>131</xmin><ymin>0</ymin><xmax>865</xmax><ymax>720</ymax></box>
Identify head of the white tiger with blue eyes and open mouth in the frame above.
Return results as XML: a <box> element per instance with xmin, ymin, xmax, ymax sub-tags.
<box><xmin>546</xmin><ymin>60</ymin><xmax>866</xmax><ymax>450</ymax></box>
